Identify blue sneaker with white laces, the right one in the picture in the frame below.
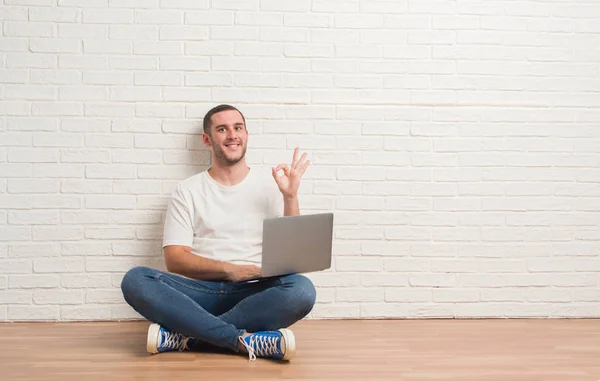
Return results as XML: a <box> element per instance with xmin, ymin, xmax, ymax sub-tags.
<box><xmin>240</xmin><ymin>328</ymin><xmax>296</xmax><ymax>361</ymax></box>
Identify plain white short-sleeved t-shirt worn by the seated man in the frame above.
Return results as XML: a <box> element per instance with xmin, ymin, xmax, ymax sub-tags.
<box><xmin>163</xmin><ymin>168</ymin><xmax>283</xmax><ymax>266</ymax></box>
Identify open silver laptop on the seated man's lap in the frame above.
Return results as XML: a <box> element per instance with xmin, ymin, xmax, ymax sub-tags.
<box><xmin>243</xmin><ymin>213</ymin><xmax>333</xmax><ymax>282</ymax></box>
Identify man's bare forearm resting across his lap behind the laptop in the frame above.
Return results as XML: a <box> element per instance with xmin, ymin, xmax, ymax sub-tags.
<box><xmin>163</xmin><ymin>245</ymin><xmax>260</xmax><ymax>282</ymax></box>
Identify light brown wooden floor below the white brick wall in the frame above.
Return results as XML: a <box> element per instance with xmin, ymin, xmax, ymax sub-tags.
<box><xmin>0</xmin><ymin>320</ymin><xmax>600</xmax><ymax>381</ymax></box>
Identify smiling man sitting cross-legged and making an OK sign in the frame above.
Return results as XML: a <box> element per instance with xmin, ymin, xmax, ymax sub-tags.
<box><xmin>121</xmin><ymin>105</ymin><xmax>316</xmax><ymax>361</ymax></box>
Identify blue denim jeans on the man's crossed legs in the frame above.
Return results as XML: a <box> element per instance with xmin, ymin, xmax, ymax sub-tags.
<box><xmin>121</xmin><ymin>267</ymin><xmax>316</xmax><ymax>352</ymax></box>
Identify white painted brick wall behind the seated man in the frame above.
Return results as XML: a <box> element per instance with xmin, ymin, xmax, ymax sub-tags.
<box><xmin>0</xmin><ymin>0</ymin><xmax>600</xmax><ymax>321</ymax></box>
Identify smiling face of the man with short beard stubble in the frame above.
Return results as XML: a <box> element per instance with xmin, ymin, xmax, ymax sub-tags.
<box><xmin>204</xmin><ymin>110</ymin><xmax>248</xmax><ymax>165</ymax></box>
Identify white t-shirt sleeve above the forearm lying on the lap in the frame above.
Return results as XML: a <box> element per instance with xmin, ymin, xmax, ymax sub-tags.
<box><xmin>163</xmin><ymin>186</ymin><xmax>194</xmax><ymax>247</ymax></box>
